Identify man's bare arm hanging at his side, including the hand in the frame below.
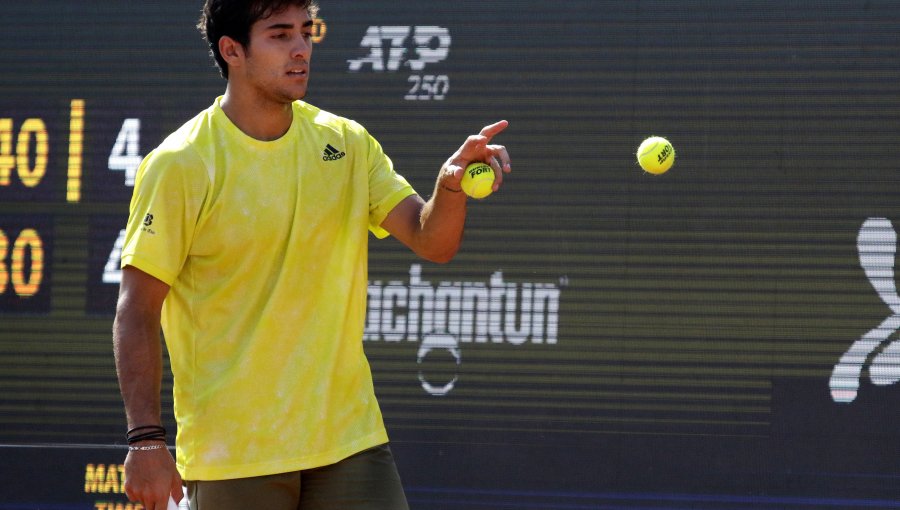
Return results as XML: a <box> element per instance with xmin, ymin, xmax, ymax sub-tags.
<box><xmin>113</xmin><ymin>267</ymin><xmax>181</xmax><ymax>510</ymax></box>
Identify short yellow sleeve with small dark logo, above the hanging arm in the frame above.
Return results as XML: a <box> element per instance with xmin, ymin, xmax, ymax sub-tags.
<box><xmin>122</xmin><ymin>147</ymin><xmax>209</xmax><ymax>286</ymax></box>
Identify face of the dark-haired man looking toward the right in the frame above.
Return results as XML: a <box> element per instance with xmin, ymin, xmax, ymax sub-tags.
<box><xmin>229</xmin><ymin>5</ymin><xmax>313</xmax><ymax>104</ymax></box>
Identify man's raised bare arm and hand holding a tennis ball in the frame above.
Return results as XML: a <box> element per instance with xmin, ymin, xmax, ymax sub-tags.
<box><xmin>381</xmin><ymin>120</ymin><xmax>512</xmax><ymax>263</ymax></box>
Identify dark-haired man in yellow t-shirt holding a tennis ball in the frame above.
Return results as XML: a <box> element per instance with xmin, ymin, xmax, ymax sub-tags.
<box><xmin>113</xmin><ymin>0</ymin><xmax>510</xmax><ymax>510</ymax></box>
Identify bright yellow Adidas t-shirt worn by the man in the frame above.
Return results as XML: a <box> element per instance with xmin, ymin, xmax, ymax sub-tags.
<box><xmin>122</xmin><ymin>98</ymin><xmax>415</xmax><ymax>480</ymax></box>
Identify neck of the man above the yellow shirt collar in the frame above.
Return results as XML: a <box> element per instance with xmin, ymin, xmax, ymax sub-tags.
<box><xmin>222</xmin><ymin>85</ymin><xmax>294</xmax><ymax>141</ymax></box>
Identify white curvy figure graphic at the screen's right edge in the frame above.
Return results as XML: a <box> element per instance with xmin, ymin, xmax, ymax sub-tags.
<box><xmin>828</xmin><ymin>218</ymin><xmax>900</xmax><ymax>403</ymax></box>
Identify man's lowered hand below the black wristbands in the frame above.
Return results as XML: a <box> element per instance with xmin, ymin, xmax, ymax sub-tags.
<box><xmin>125</xmin><ymin>448</ymin><xmax>184</xmax><ymax>510</ymax></box>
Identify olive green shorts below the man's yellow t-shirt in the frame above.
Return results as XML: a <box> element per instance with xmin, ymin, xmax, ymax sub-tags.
<box><xmin>186</xmin><ymin>444</ymin><xmax>409</xmax><ymax>510</ymax></box>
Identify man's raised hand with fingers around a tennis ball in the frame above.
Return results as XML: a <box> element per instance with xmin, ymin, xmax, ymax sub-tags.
<box><xmin>440</xmin><ymin>120</ymin><xmax>512</xmax><ymax>191</ymax></box>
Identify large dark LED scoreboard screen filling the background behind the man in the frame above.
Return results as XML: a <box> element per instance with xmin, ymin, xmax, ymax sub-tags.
<box><xmin>0</xmin><ymin>0</ymin><xmax>900</xmax><ymax>510</ymax></box>
